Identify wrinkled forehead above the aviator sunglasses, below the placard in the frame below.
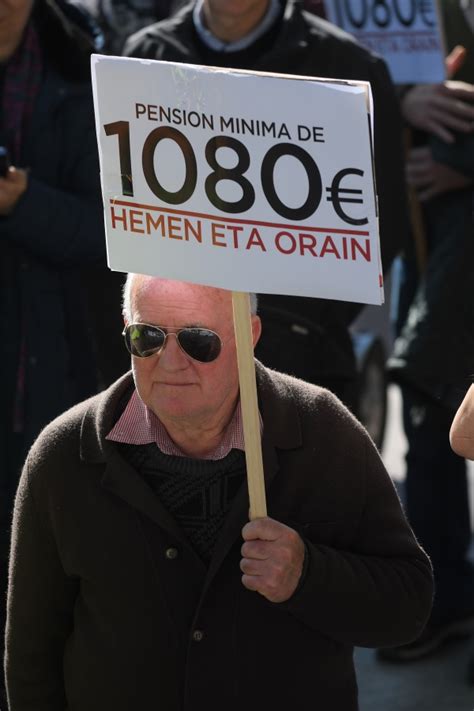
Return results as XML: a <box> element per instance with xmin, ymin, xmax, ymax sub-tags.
<box><xmin>131</xmin><ymin>275</ymin><xmax>232</xmax><ymax>325</ymax></box>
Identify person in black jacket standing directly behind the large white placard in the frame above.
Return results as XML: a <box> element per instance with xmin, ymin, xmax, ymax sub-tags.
<box><xmin>124</xmin><ymin>0</ymin><xmax>408</xmax><ymax>409</ymax></box>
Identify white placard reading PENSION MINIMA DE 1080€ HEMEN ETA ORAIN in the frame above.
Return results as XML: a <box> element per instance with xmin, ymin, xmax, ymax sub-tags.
<box><xmin>92</xmin><ymin>55</ymin><xmax>383</xmax><ymax>304</ymax></box>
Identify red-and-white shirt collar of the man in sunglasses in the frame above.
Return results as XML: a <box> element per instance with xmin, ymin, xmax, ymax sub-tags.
<box><xmin>106</xmin><ymin>390</ymin><xmax>256</xmax><ymax>460</ymax></box>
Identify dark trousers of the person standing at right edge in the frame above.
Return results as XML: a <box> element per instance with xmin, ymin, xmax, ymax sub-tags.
<box><xmin>402</xmin><ymin>387</ymin><xmax>474</xmax><ymax>622</ymax></box>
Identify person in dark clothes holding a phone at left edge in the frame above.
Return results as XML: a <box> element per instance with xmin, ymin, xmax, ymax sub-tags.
<box><xmin>0</xmin><ymin>0</ymin><xmax>105</xmax><ymax>709</ymax></box>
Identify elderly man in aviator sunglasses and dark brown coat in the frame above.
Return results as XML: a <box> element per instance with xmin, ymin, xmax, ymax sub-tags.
<box><xmin>6</xmin><ymin>276</ymin><xmax>432</xmax><ymax>711</ymax></box>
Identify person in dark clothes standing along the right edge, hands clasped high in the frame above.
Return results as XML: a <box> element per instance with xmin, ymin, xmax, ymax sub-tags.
<box><xmin>380</xmin><ymin>0</ymin><xmax>474</xmax><ymax>661</ymax></box>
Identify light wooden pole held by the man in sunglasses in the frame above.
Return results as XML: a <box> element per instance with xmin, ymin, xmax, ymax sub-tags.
<box><xmin>232</xmin><ymin>291</ymin><xmax>267</xmax><ymax>520</ymax></box>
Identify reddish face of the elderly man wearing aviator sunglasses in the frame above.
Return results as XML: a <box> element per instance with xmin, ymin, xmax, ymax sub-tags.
<box><xmin>131</xmin><ymin>277</ymin><xmax>260</xmax><ymax>424</ymax></box>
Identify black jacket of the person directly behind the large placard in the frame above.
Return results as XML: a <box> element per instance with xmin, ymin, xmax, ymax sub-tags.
<box><xmin>125</xmin><ymin>0</ymin><xmax>408</xmax><ymax>390</ymax></box>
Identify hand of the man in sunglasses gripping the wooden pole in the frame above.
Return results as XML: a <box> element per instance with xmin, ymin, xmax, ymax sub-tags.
<box><xmin>240</xmin><ymin>518</ymin><xmax>305</xmax><ymax>602</ymax></box>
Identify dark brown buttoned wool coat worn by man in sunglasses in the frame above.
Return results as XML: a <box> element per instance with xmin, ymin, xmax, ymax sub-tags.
<box><xmin>7</xmin><ymin>365</ymin><xmax>432</xmax><ymax>711</ymax></box>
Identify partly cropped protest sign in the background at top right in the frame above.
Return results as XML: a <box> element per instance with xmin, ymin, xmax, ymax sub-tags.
<box><xmin>324</xmin><ymin>0</ymin><xmax>445</xmax><ymax>84</ymax></box>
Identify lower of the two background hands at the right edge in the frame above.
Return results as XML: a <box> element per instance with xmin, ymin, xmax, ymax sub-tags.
<box><xmin>406</xmin><ymin>147</ymin><xmax>472</xmax><ymax>202</ymax></box>
